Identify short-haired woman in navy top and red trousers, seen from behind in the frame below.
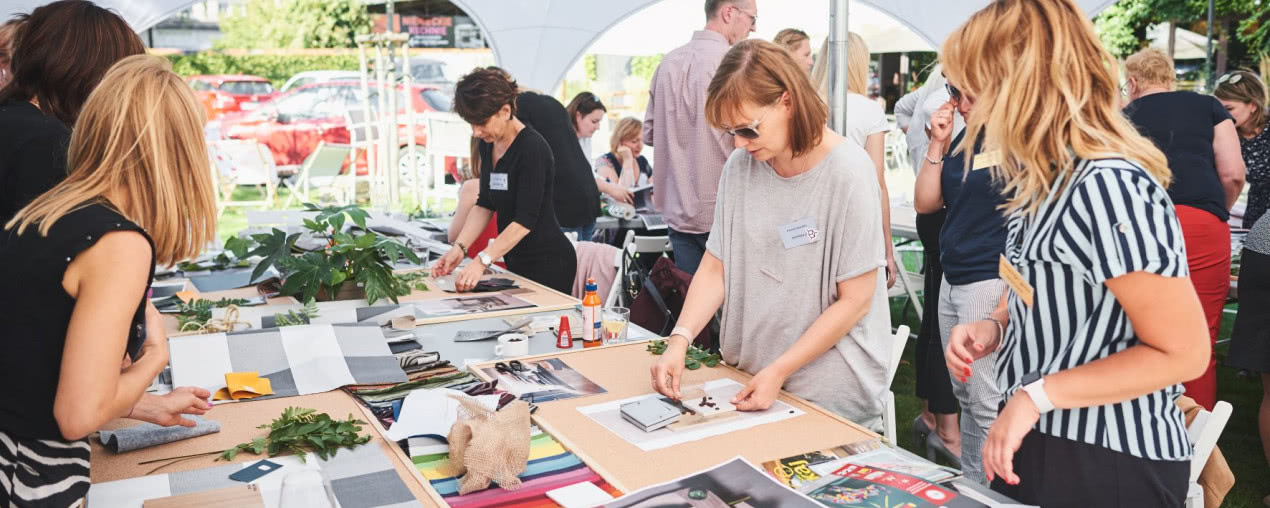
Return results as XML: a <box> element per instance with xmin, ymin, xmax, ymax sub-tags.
<box><xmin>1124</xmin><ymin>48</ymin><xmax>1243</xmax><ymax>410</ymax></box>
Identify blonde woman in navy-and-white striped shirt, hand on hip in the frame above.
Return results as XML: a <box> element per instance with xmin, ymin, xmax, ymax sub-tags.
<box><xmin>941</xmin><ymin>0</ymin><xmax>1209</xmax><ymax>507</ymax></box>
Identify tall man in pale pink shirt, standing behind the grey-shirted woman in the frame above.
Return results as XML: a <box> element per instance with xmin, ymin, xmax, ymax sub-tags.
<box><xmin>644</xmin><ymin>0</ymin><xmax>758</xmax><ymax>273</ymax></box>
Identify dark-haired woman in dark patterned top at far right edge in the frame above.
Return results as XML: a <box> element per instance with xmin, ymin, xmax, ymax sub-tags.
<box><xmin>1213</xmin><ymin>71</ymin><xmax>1270</xmax><ymax>229</ymax></box>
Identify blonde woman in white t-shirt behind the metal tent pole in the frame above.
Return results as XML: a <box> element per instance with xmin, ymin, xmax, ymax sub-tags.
<box><xmin>812</xmin><ymin>32</ymin><xmax>899</xmax><ymax>287</ymax></box>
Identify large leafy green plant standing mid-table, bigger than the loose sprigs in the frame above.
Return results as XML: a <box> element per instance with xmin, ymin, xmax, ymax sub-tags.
<box><xmin>250</xmin><ymin>203</ymin><xmax>419</xmax><ymax>305</ymax></box>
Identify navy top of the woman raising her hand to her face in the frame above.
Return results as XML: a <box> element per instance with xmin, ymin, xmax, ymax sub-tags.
<box><xmin>940</xmin><ymin>131</ymin><xmax>1006</xmax><ymax>286</ymax></box>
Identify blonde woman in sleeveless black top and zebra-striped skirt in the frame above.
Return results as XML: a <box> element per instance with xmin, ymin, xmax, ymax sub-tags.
<box><xmin>0</xmin><ymin>55</ymin><xmax>216</xmax><ymax>505</ymax></box>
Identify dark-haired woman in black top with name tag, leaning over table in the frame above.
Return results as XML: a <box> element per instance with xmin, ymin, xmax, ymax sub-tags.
<box><xmin>432</xmin><ymin>67</ymin><xmax>582</xmax><ymax>293</ymax></box>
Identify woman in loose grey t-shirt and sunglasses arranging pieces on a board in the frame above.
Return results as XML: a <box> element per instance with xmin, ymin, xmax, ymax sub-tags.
<box><xmin>652</xmin><ymin>41</ymin><xmax>890</xmax><ymax>429</ymax></box>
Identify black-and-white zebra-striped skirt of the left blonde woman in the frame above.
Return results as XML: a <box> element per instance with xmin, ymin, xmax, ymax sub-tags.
<box><xmin>0</xmin><ymin>431</ymin><xmax>89</xmax><ymax>507</ymax></box>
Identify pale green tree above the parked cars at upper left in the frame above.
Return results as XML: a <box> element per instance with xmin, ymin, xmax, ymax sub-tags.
<box><xmin>216</xmin><ymin>0</ymin><xmax>371</xmax><ymax>50</ymax></box>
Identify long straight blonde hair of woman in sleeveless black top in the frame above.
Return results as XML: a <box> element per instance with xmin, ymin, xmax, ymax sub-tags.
<box><xmin>5</xmin><ymin>55</ymin><xmax>216</xmax><ymax>265</ymax></box>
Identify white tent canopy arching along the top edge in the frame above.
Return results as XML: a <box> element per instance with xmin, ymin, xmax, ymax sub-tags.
<box><xmin>7</xmin><ymin>0</ymin><xmax>1114</xmax><ymax>90</ymax></box>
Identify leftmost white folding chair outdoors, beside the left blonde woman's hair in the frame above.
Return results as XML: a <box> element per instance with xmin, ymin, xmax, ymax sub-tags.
<box><xmin>207</xmin><ymin>140</ymin><xmax>278</xmax><ymax>216</ymax></box>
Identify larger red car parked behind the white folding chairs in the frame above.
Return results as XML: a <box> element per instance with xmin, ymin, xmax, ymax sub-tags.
<box><xmin>213</xmin><ymin>81</ymin><xmax>458</xmax><ymax>180</ymax></box>
